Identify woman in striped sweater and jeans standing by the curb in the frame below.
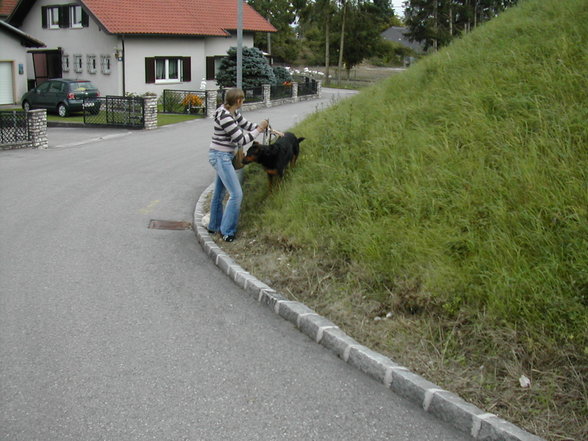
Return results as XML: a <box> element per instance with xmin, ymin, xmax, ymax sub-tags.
<box><xmin>208</xmin><ymin>89</ymin><xmax>268</xmax><ymax>242</ymax></box>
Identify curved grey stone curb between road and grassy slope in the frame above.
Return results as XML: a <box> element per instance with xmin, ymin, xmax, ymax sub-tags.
<box><xmin>194</xmin><ymin>184</ymin><xmax>545</xmax><ymax>441</ymax></box>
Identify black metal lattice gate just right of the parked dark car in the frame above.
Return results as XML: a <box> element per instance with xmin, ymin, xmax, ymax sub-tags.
<box><xmin>84</xmin><ymin>95</ymin><xmax>145</xmax><ymax>129</ymax></box>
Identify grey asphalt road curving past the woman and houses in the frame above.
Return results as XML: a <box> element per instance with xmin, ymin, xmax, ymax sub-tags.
<box><xmin>0</xmin><ymin>91</ymin><xmax>469</xmax><ymax>441</ymax></box>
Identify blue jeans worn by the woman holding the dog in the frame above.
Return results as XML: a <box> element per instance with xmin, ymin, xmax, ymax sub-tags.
<box><xmin>208</xmin><ymin>149</ymin><xmax>243</xmax><ymax>236</ymax></box>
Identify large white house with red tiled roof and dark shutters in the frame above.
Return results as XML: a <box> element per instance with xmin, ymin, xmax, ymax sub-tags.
<box><xmin>8</xmin><ymin>0</ymin><xmax>276</xmax><ymax>99</ymax></box>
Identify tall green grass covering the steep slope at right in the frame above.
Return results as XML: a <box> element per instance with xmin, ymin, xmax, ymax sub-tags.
<box><xmin>239</xmin><ymin>0</ymin><xmax>588</xmax><ymax>439</ymax></box>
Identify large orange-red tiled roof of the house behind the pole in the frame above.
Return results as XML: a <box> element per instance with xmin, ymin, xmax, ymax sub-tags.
<box><xmin>81</xmin><ymin>0</ymin><xmax>276</xmax><ymax>36</ymax></box>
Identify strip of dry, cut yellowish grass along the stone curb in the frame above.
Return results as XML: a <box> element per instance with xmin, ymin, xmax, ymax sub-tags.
<box><xmin>218</xmin><ymin>226</ymin><xmax>588</xmax><ymax>441</ymax></box>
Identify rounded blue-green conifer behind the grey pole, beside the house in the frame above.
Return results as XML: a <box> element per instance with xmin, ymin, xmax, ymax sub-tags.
<box><xmin>216</xmin><ymin>47</ymin><xmax>276</xmax><ymax>89</ymax></box>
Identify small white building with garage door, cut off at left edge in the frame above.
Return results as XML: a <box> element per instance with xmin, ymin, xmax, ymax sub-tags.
<box><xmin>0</xmin><ymin>20</ymin><xmax>45</xmax><ymax>104</ymax></box>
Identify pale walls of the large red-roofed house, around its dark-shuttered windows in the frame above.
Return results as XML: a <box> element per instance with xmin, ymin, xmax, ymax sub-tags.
<box><xmin>21</xmin><ymin>0</ymin><xmax>253</xmax><ymax>96</ymax></box>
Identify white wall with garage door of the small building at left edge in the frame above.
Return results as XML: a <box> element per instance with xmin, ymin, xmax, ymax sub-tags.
<box><xmin>0</xmin><ymin>30</ymin><xmax>27</xmax><ymax>104</ymax></box>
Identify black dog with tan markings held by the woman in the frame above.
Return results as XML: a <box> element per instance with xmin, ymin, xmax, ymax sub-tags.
<box><xmin>243</xmin><ymin>132</ymin><xmax>304</xmax><ymax>189</ymax></box>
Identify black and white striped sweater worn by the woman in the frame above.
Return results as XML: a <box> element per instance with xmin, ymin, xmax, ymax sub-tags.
<box><xmin>210</xmin><ymin>105</ymin><xmax>261</xmax><ymax>152</ymax></box>
